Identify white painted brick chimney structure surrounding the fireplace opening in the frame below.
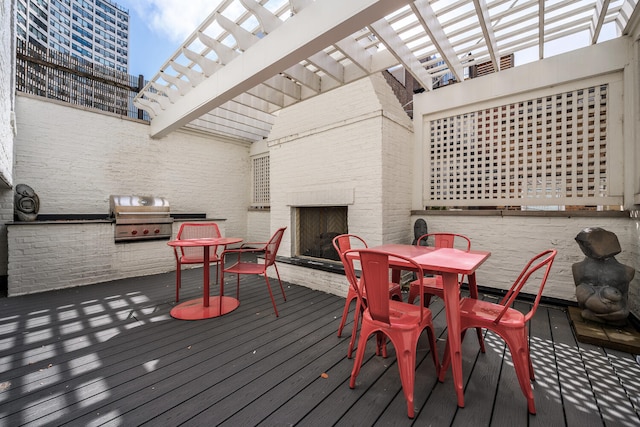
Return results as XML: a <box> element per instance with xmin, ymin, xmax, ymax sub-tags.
<box><xmin>267</xmin><ymin>75</ymin><xmax>413</xmax><ymax>256</ymax></box>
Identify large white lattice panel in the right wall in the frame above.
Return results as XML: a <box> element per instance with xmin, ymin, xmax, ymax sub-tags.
<box><xmin>427</xmin><ymin>84</ymin><xmax>609</xmax><ymax>206</ymax></box>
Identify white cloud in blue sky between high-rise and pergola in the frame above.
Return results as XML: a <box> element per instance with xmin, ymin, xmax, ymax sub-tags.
<box><xmin>131</xmin><ymin>0</ymin><xmax>222</xmax><ymax>44</ymax></box>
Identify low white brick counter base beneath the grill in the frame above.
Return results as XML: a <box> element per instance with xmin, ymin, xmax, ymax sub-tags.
<box><xmin>7</xmin><ymin>221</ymin><xmax>227</xmax><ymax>296</ymax></box>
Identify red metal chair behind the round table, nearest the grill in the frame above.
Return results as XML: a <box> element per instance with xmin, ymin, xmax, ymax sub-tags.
<box><xmin>173</xmin><ymin>222</ymin><xmax>221</xmax><ymax>302</ymax></box>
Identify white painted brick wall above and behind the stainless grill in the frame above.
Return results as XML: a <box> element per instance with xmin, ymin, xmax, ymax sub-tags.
<box><xmin>15</xmin><ymin>96</ymin><xmax>250</xmax><ymax>236</ymax></box>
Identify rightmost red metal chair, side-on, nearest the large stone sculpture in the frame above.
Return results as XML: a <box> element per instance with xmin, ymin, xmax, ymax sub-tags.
<box><xmin>439</xmin><ymin>249</ymin><xmax>557</xmax><ymax>414</ymax></box>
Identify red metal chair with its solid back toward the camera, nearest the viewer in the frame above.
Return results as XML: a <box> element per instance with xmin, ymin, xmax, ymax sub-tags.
<box><xmin>344</xmin><ymin>249</ymin><xmax>440</xmax><ymax>418</ymax></box>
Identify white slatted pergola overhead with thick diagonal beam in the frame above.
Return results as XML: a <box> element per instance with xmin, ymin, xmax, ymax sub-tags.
<box><xmin>134</xmin><ymin>0</ymin><xmax>638</xmax><ymax>141</ymax></box>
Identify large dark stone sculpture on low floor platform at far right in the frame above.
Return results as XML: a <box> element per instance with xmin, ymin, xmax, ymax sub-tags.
<box><xmin>572</xmin><ymin>227</ymin><xmax>635</xmax><ymax>326</ymax></box>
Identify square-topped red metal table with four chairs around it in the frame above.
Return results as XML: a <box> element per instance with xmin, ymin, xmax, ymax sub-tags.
<box><xmin>350</xmin><ymin>244</ymin><xmax>491</xmax><ymax>408</ymax></box>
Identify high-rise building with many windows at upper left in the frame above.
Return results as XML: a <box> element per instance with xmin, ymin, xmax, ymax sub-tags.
<box><xmin>16</xmin><ymin>0</ymin><xmax>129</xmax><ymax>73</ymax></box>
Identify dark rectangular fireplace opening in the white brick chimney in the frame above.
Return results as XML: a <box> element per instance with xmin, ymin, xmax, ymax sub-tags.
<box><xmin>296</xmin><ymin>206</ymin><xmax>349</xmax><ymax>261</ymax></box>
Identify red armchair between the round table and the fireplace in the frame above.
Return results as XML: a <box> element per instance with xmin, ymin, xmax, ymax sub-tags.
<box><xmin>220</xmin><ymin>227</ymin><xmax>287</xmax><ymax>317</ymax></box>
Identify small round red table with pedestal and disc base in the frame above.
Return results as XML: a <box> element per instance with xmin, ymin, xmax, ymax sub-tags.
<box><xmin>167</xmin><ymin>237</ymin><xmax>242</xmax><ymax>320</ymax></box>
